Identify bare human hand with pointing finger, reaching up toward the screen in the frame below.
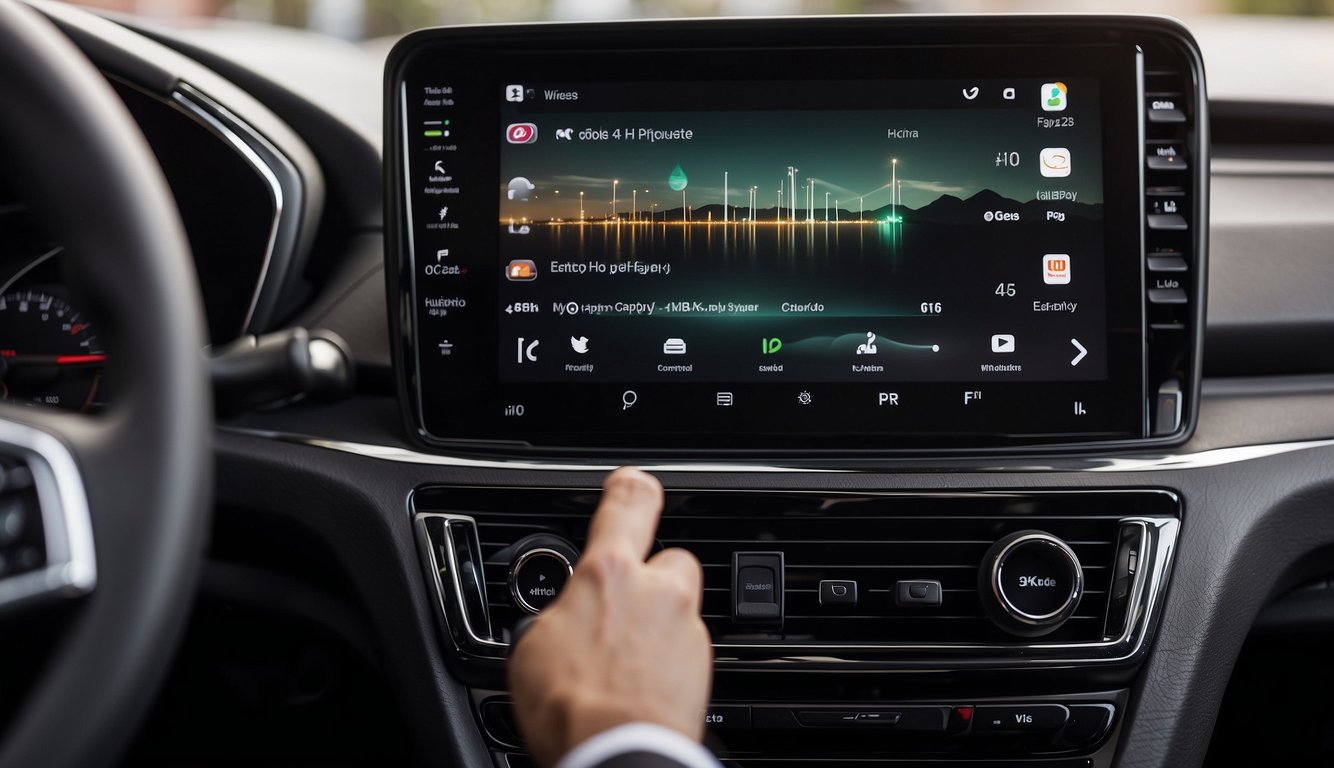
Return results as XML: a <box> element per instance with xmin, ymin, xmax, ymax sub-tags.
<box><xmin>510</xmin><ymin>467</ymin><xmax>712</xmax><ymax>765</ymax></box>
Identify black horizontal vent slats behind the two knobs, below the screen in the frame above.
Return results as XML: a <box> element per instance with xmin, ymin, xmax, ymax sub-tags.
<box><xmin>418</xmin><ymin>488</ymin><xmax>1175</xmax><ymax>645</ymax></box>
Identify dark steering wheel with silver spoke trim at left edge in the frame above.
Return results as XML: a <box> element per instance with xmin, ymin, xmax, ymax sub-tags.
<box><xmin>0</xmin><ymin>0</ymin><xmax>212</xmax><ymax>767</ymax></box>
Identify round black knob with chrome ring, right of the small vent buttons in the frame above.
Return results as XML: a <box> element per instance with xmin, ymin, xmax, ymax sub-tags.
<box><xmin>978</xmin><ymin>531</ymin><xmax>1083</xmax><ymax>637</ymax></box>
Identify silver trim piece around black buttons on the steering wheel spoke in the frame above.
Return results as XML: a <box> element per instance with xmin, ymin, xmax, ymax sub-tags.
<box><xmin>0</xmin><ymin>417</ymin><xmax>97</xmax><ymax>611</ymax></box>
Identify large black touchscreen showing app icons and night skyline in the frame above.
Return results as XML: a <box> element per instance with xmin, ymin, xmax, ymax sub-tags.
<box><xmin>388</xmin><ymin>18</ymin><xmax>1179</xmax><ymax>449</ymax></box>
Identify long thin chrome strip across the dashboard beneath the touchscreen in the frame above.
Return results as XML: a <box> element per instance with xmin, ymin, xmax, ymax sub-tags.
<box><xmin>219</xmin><ymin>427</ymin><xmax>1334</xmax><ymax>473</ymax></box>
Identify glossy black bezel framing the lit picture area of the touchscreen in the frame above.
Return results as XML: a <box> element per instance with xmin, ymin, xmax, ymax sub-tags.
<box><xmin>387</xmin><ymin>20</ymin><xmax>1146</xmax><ymax>453</ymax></box>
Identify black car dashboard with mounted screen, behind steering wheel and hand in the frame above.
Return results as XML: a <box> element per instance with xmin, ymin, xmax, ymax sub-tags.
<box><xmin>0</xmin><ymin>5</ymin><xmax>1334</xmax><ymax>768</ymax></box>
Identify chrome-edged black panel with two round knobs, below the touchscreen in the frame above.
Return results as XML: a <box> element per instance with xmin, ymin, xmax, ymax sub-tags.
<box><xmin>414</xmin><ymin>487</ymin><xmax>1179</xmax><ymax>668</ymax></box>
